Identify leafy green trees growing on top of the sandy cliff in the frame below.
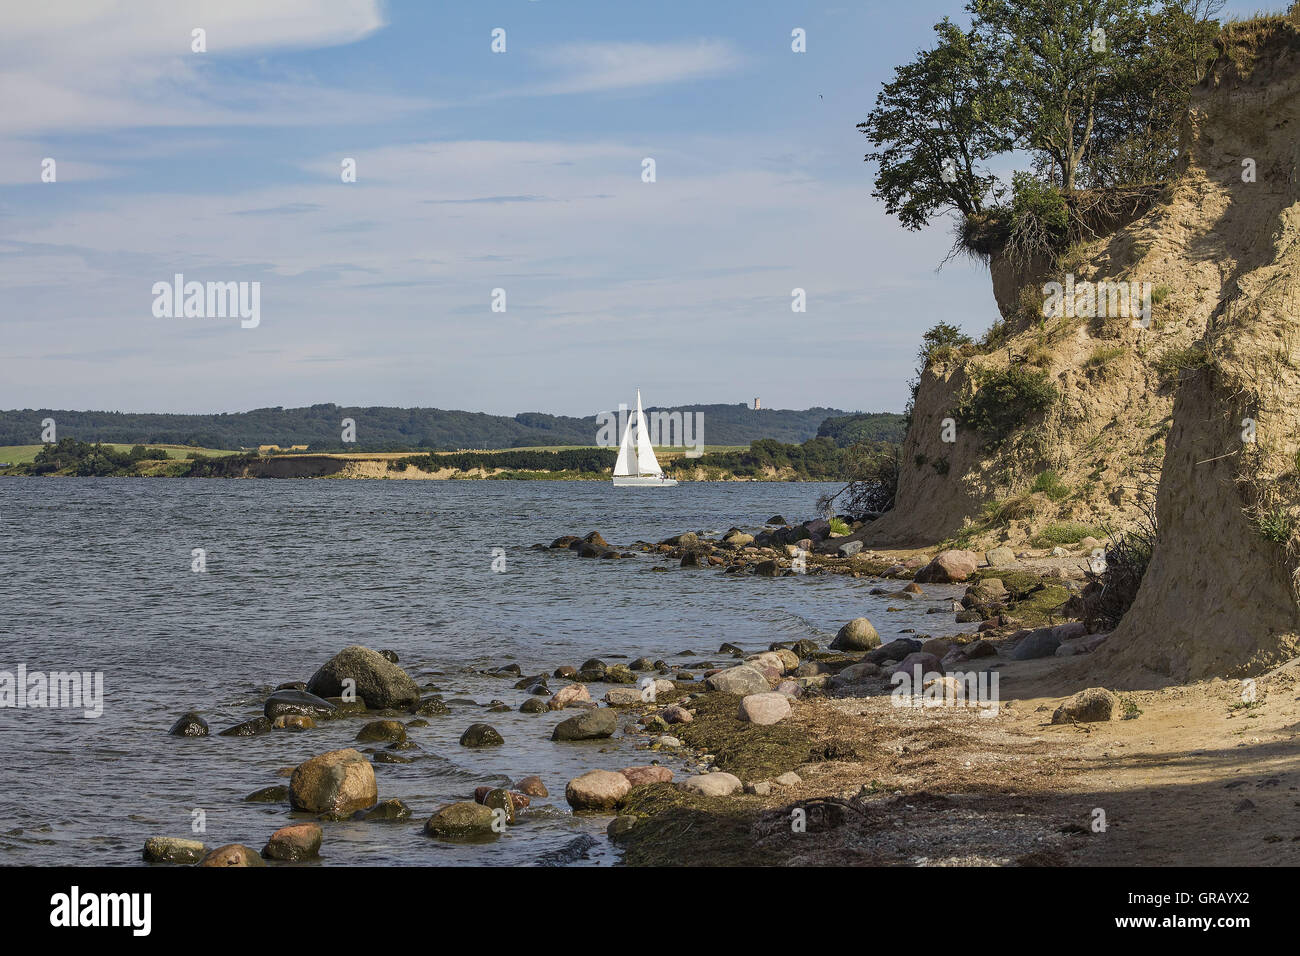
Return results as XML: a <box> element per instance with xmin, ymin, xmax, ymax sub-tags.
<box><xmin>858</xmin><ymin>0</ymin><xmax>1222</xmax><ymax>229</ymax></box>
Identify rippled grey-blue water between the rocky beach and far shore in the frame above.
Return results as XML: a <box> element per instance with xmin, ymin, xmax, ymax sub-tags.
<box><xmin>0</xmin><ymin>479</ymin><xmax>957</xmax><ymax>865</ymax></box>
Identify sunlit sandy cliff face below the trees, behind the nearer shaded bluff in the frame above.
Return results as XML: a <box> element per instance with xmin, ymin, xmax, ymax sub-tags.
<box><xmin>866</xmin><ymin>20</ymin><xmax>1300</xmax><ymax>604</ymax></box>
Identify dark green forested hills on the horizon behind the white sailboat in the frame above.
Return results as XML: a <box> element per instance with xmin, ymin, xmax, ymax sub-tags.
<box><xmin>0</xmin><ymin>405</ymin><xmax>902</xmax><ymax>451</ymax></box>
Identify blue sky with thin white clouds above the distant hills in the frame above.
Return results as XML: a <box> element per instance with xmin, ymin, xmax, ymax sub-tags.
<box><xmin>0</xmin><ymin>0</ymin><xmax>1279</xmax><ymax>415</ymax></box>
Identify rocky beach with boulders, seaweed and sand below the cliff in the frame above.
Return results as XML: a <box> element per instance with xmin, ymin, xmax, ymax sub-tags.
<box><xmin>116</xmin><ymin>515</ymin><xmax>1297</xmax><ymax>866</ymax></box>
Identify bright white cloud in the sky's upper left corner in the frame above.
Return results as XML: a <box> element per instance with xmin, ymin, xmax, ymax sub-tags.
<box><xmin>0</xmin><ymin>0</ymin><xmax>416</xmax><ymax>137</ymax></box>
